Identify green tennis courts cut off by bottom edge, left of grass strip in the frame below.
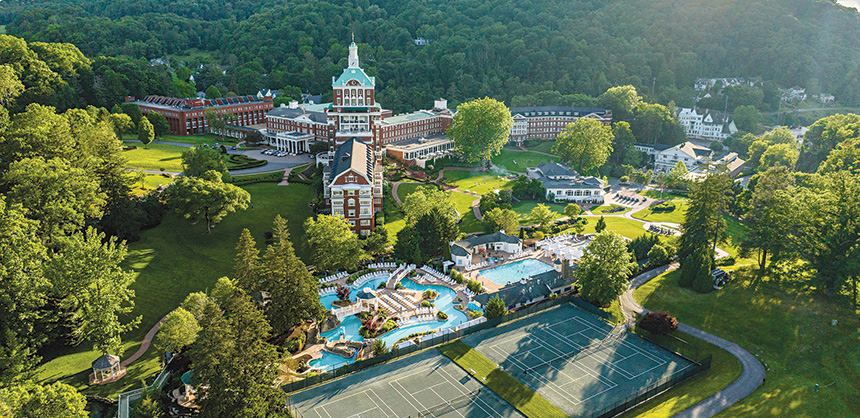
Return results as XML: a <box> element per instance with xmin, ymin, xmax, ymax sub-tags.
<box><xmin>290</xmin><ymin>350</ymin><xmax>522</xmax><ymax>418</ymax></box>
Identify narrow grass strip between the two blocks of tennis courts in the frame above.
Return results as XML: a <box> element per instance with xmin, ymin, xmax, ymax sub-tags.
<box><xmin>439</xmin><ymin>340</ymin><xmax>567</xmax><ymax>418</ymax></box>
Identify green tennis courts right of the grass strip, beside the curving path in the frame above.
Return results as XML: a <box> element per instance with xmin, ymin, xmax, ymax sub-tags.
<box><xmin>463</xmin><ymin>304</ymin><xmax>693</xmax><ymax>416</ymax></box>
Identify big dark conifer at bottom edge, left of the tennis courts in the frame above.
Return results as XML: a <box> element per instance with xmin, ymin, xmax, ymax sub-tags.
<box><xmin>191</xmin><ymin>287</ymin><xmax>288</xmax><ymax>418</ymax></box>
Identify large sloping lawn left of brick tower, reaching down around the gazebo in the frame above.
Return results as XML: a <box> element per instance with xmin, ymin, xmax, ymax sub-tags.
<box><xmin>38</xmin><ymin>183</ymin><xmax>313</xmax><ymax>397</ymax></box>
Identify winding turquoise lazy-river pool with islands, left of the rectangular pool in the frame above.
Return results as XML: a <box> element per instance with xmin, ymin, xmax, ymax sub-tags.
<box><xmin>310</xmin><ymin>278</ymin><xmax>467</xmax><ymax>370</ymax></box>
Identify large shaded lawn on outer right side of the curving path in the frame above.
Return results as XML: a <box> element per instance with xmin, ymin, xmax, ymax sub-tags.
<box><xmin>635</xmin><ymin>270</ymin><xmax>860</xmax><ymax>418</ymax></box>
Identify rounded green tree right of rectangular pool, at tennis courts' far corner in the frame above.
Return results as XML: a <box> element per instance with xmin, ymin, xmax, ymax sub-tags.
<box><xmin>576</xmin><ymin>231</ymin><xmax>636</xmax><ymax>306</ymax></box>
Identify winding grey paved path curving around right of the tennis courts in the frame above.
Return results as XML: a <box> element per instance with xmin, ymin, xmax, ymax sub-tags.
<box><xmin>619</xmin><ymin>262</ymin><xmax>765</xmax><ymax>418</ymax></box>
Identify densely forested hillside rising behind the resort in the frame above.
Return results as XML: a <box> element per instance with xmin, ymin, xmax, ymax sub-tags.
<box><xmin>5</xmin><ymin>0</ymin><xmax>860</xmax><ymax>111</ymax></box>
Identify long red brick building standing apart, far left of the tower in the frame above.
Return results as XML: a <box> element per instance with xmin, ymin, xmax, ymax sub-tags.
<box><xmin>126</xmin><ymin>96</ymin><xmax>273</xmax><ymax>135</ymax></box>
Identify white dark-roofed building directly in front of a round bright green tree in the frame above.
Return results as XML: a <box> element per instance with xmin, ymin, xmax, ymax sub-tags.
<box><xmin>527</xmin><ymin>163</ymin><xmax>604</xmax><ymax>203</ymax></box>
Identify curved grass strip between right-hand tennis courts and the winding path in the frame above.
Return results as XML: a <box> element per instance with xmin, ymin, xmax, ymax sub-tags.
<box><xmin>621</xmin><ymin>332</ymin><xmax>743</xmax><ymax>418</ymax></box>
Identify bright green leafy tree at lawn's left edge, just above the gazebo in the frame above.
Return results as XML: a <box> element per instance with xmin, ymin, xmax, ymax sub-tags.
<box><xmin>49</xmin><ymin>227</ymin><xmax>141</xmax><ymax>354</ymax></box>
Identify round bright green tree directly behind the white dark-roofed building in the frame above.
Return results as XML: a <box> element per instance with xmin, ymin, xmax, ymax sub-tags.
<box><xmin>552</xmin><ymin>118</ymin><xmax>614</xmax><ymax>173</ymax></box>
